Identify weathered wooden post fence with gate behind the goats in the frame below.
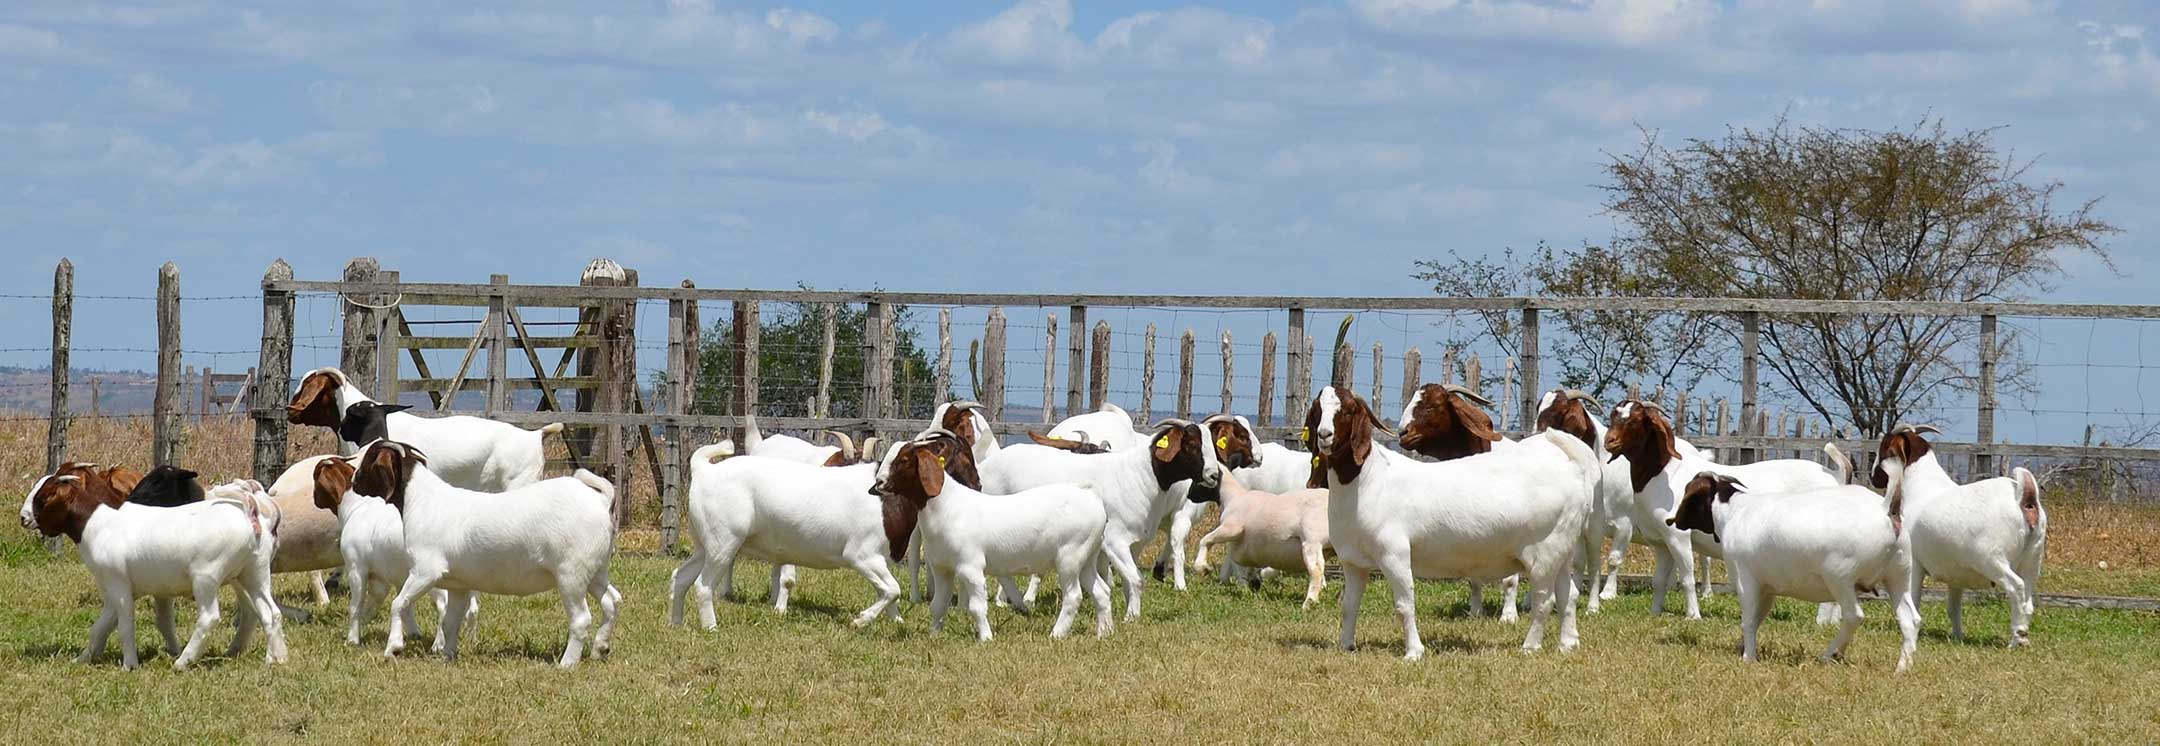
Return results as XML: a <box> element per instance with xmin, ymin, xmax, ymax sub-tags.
<box><xmin>25</xmin><ymin>257</ymin><xmax>2160</xmax><ymax>547</ymax></box>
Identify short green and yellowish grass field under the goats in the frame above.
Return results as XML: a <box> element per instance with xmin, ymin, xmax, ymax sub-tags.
<box><xmin>0</xmin><ymin>415</ymin><xmax>2160</xmax><ymax>744</ymax></box>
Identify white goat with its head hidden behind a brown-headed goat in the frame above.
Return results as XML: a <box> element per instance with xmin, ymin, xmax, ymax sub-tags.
<box><xmin>667</xmin><ymin>438</ymin><xmax>950</xmax><ymax>629</ymax></box>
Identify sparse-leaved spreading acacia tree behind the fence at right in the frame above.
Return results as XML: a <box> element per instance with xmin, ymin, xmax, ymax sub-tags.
<box><xmin>1421</xmin><ymin>119</ymin><xmax>2117</xmax><ymax>435</ymax></box>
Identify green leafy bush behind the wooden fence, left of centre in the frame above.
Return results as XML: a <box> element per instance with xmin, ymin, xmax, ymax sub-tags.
<box><xmin>696</xmin><ymin>305</ymin><xmax>950</xmax><ymax>417</ymax></box>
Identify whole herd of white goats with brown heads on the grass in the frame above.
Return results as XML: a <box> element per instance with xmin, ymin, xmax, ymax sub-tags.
<box><xmin>22</xmin><ymin>368</ymin><xmax>2048</xmax><ymax>670</ymax></box>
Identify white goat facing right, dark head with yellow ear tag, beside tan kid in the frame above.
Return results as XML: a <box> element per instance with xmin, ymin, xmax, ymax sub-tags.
<box><xmin>981</xmin><ymin>419</ymin><xmax>1223</xmax><ymax>621</ymax></box>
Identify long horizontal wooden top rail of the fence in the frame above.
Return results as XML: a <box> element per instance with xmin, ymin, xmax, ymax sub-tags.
<box><xmin>264</xmin><ymin>279</ymin><xmax>2160</xmax><ymax>318</ymax></box>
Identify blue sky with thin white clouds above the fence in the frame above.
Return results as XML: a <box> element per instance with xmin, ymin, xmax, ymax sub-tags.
<box><xmin>0</xmin><ymin>0</ymin><xmax>2160</xmax><ymax>441</ymax></box>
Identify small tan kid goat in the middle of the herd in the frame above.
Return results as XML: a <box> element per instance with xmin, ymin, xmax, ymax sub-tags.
<box><xmin>1192</xmin><ymin>469</ymin><xmax>1328</xmax><ymax>610</ymax></box>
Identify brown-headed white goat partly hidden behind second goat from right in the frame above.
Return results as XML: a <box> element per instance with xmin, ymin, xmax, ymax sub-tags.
<box><xmin>1605</xmin><ymin>400</ymin><xmax>1853</xmax><ymax>618</ymax></box>
